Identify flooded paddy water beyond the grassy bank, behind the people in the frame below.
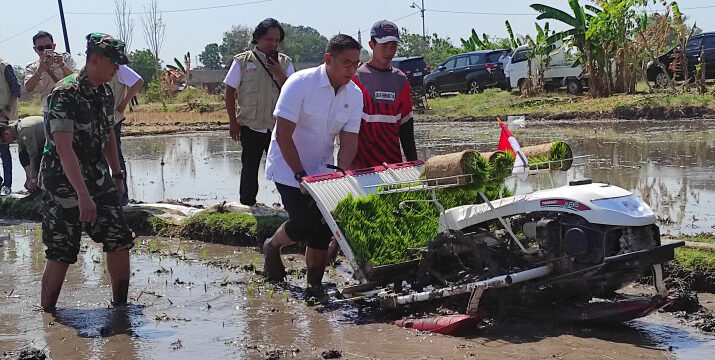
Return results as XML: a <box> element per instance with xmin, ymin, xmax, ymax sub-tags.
<box><xmin>109</xmin><ymin>119</ymin><xmax>715</xmax><ymax>235</ymax></box>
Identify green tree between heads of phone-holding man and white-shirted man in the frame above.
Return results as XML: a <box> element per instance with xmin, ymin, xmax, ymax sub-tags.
<box><xmin>280</xmin><ymin>23</ymin><xmax>328</xmax><ymax>62</ymax></box>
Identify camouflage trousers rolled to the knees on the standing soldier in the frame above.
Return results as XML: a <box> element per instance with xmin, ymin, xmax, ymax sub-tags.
<box><xmin>42</xmin><ymin>191</ymin><xmax>134</xmax><ymax>264</ymax></box>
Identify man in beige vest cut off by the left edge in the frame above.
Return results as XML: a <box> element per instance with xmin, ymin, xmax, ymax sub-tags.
<box><xmin>0</xmin><ymin>59</ymin><xmax>20</xmax><ymax>196</ymax></box>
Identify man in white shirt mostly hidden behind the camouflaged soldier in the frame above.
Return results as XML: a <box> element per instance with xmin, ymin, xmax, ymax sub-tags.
<box><xmin>109</xmin><ymin>65</ymin><xmax>144</xmax><ymax>206</ymax></box>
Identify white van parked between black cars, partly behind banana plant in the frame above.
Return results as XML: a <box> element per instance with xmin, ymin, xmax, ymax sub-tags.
<box><xmin>504</xmin><ymin>43</ymin><xmax>588</xmax><ymax>95</ymax></box>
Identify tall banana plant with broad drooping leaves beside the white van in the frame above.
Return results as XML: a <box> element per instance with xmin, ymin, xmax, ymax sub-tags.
<box><xmin>531</xmin><ymin>0</ymin><xmax>608</xmax><ymax>97</ymax></box>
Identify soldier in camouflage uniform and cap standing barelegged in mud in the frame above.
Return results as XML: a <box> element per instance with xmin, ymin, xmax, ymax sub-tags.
<box><xmin>39</xmin><ymin>33</ymin><xmax>134</xmax><ymax>311</ymax></box>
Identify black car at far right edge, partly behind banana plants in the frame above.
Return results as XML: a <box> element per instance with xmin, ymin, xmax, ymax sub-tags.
<box><xmin>646</xmin><ymin>31</ymin><xmax>715</xmax><ymax>87</ymax></box>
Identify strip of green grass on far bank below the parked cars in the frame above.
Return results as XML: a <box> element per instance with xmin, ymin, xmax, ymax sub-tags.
<box><xmin>429</xmin><ymin>84</ymin><xmax>715</xmax><ymax>117</ymax></box>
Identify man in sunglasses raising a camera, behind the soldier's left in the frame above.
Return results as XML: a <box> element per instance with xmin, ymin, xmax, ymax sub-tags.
<box><xmin>25</xmin><ymin>31</ymin><xmax>77</xmax><ymax>117</ymax></box>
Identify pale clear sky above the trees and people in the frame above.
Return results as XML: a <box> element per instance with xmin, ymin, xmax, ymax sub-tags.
<box><xmin>0</xmin><ymin>0</ymin><xmax>715</xmax><ymax>66</ymax></box>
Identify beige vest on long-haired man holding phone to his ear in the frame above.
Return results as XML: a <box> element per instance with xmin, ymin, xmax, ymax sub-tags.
<box><xmin>235</xmin><ymin>50</ymin><xmax>291</xmax><ymax>130</ymax></box>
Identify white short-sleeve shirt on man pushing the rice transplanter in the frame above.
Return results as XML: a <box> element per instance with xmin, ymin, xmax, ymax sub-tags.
<box><xmin>266</xmin><ymin>64</ymin><xmax>363</xmax><ymax>187</ymax></box>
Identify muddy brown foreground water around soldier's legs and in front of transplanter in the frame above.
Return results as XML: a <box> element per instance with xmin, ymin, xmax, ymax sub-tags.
<box><xmin>0</xmin><ymin>224</ymin><xmax>715</xmax><ymax>359</ymax></box>
